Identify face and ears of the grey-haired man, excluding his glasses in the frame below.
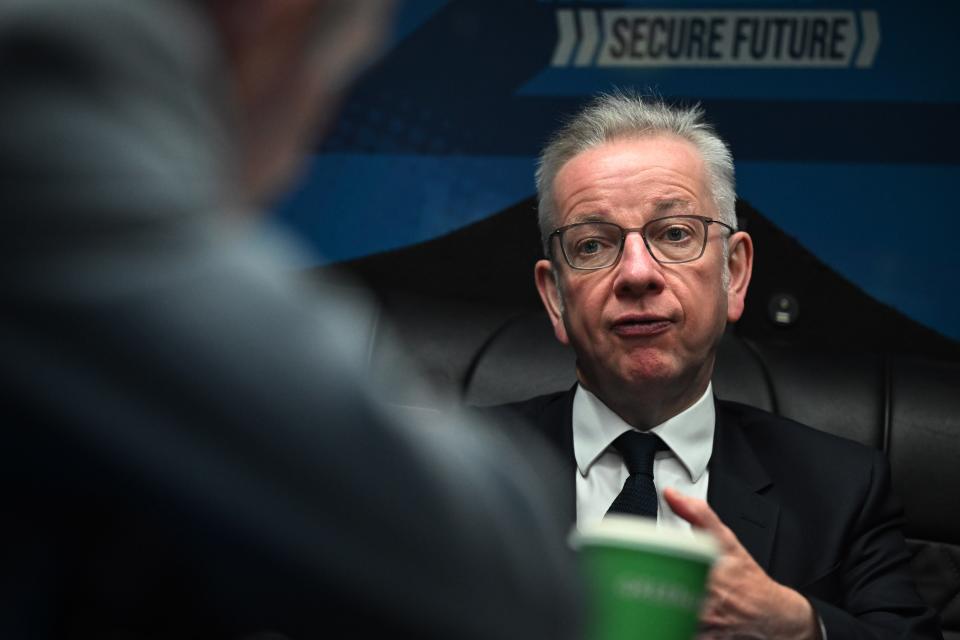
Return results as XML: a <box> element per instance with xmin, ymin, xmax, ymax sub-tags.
<box><xmin>536</xmin><ymin>135</ymin><xmax>752</xmax><ymax>426</ymax></box>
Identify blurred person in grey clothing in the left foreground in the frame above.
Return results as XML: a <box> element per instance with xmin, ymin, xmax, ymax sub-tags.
<box><xmin>0</xmin><ymin>0</ymin><xmax>576</xmax><ymax>639</ymax></box>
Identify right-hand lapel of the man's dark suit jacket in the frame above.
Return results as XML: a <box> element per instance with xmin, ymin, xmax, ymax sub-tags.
<box><xmin>707</xmin><ymin>402</ymin><xmax>780</xmax><ymax>572</ymax></box>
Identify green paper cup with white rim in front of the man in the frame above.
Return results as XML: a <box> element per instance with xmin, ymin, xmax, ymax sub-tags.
<box><xmin>572</xmin><ymin>515</ymin><xmax>717</xmax><ymax>640</ymax></box>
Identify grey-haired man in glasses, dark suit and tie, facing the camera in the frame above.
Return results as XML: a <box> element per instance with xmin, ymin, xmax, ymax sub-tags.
<box><xmin>498</xmin><ymin>94</ymin><xmax>940</xmax><ymax>640</ymax></box>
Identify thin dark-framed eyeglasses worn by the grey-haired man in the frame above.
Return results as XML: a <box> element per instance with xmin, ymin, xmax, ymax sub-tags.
<box><xmin>549</xmin><ymin>216</ymin><xmax>735</xmax><ymax>270</ymax></box>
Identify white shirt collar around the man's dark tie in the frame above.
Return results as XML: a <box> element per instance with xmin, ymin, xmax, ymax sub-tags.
<box><xmin>573</xmin><ymin>383</ymin><xmax>716</xmax><ymax>482</ymax></box>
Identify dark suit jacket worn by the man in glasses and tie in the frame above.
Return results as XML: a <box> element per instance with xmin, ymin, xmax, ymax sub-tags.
<box><xmin>496</xmin><ymin>387</ymin><xmax>941</xmax><ymax>640</ymax></box>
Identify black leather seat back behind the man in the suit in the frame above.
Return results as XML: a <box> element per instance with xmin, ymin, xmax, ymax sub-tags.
<box><xmin>362</xmin><ymin>295</ymin><xmax>960</xmax><ymax>640</ymax></box>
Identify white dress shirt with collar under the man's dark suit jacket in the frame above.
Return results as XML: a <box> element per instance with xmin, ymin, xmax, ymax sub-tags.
<box><xmin>573</xmin><ymin>384</ymin><xmax>716</xmax><ymax>531</ymax></box>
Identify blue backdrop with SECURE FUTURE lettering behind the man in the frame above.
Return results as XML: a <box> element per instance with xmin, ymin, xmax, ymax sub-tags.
<box><xmin>278</xmin><ymin>0</ymin><xmax>960</xmax><ymax>339</ymax></box>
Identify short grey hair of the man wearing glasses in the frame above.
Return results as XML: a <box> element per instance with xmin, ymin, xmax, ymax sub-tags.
<box><xmin>536</xmin><ymin>90</ymin><xmax>737</xmax><ymax>252</ymax></box>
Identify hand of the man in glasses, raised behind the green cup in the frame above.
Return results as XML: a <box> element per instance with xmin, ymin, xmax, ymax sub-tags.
<box><xmin>663</xmin><ymin>488</ymin><xmax>819</xmax><ymax>640</ymax></box>
